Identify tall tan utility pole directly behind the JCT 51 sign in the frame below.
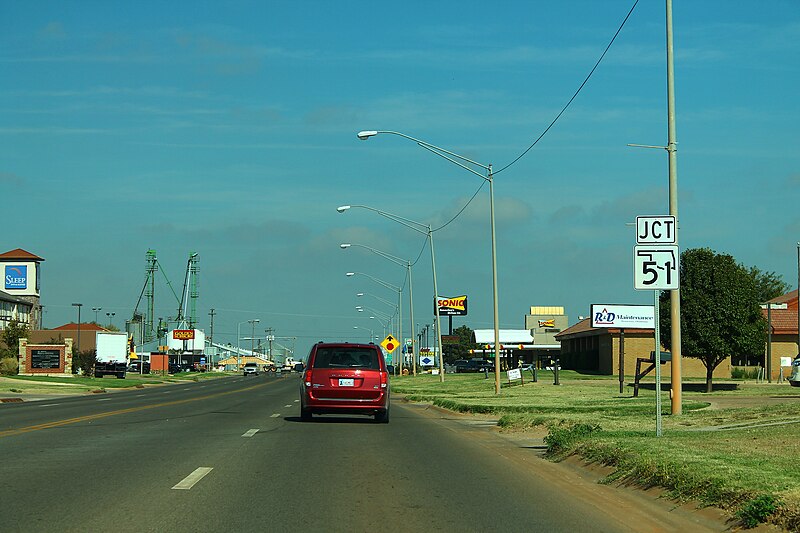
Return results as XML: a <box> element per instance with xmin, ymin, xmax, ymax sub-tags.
<box><xmin>656</xmin><ymin>0</ymin><xmax>683</xmax><ymax>415</ymax></box>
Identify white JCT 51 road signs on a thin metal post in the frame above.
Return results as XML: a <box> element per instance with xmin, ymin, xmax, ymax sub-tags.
<box><xmin>633</xmin><ymin>215</ymin><xmax>680</xmax><ymax>437</ymax></box>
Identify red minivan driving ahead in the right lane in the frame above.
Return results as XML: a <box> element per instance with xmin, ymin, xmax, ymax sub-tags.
<box><xmin>300</xmin><ymin>342</ymin><xmax>389</xmax><ymax>423</ymax></box>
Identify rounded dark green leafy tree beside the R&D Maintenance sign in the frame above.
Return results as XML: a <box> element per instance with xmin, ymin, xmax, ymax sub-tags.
<box><xmin>660</xmin><ymin>248</ymin><xmax>774</xmax><ymax>392</ymax></box>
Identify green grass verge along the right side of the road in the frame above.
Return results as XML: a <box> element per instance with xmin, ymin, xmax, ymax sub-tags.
<box><xmin>392</xmin><ymin>371</ymin><xmax>800</xmax><ymax>531</ymax></box>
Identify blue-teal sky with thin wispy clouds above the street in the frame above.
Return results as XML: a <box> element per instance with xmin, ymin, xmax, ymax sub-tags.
<box><xmin>0</xmin><ymin>0</ymin><xmax>800</xmax><ymax>357</ymax></box>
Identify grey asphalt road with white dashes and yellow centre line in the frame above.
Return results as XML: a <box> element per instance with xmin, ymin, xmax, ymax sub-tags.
<box><xmin>0</xmin><ymin>375</ymin><xmax>725</xmax><ymax>533</ymax></box>
